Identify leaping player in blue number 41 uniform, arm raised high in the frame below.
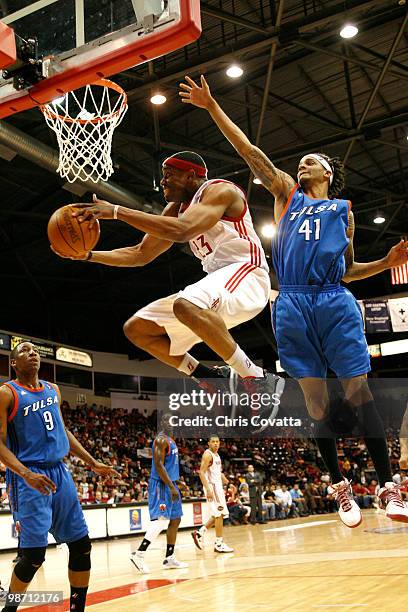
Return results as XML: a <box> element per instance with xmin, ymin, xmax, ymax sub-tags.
<box><xmin>180</xmin><ymin>77</ymin><xmax>408</xmax><ymax>527</ymax></box>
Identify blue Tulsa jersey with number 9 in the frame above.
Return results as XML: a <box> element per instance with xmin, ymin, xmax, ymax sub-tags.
<box><xmin>4</xmin><ymin>380</ymin><xmax>69</xmax><ymax>465</ymax></box>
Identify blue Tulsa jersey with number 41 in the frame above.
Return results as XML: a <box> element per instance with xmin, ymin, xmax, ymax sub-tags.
<box><xmin>272</xmin><ymin>185</ymin><xmax>351</xmax><ymax>287</ymax></box>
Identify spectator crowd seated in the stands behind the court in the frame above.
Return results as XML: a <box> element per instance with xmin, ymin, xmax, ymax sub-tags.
<box><xmin>0</xmin><ymin>401</ymin><xmax>408</xmax><ymax>524</ymax></box>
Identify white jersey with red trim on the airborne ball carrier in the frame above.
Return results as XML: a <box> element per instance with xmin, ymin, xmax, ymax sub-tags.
<box><xmin>179</xmin><ymin>179</ymin><xmax>269</xmax><ymax>274</ymax></box>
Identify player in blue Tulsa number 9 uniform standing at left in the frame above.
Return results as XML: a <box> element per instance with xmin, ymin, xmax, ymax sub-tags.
<box><xmin>0</xmin><ymin>342</ymin><xmax>119</xmax><ymax>612</ymax></box>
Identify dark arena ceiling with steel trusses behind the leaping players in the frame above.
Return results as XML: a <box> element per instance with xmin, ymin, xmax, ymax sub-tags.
<box><xmin>0</xmin><ymin>0</ymin><xmax>408</xmax><ymax>361</ymax></box>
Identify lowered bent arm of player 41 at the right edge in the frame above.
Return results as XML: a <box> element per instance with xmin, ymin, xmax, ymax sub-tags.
<box><xmin>343</xmin><ymin>211</ymin><xmax>408</xmax><ymax>283</ymax></box>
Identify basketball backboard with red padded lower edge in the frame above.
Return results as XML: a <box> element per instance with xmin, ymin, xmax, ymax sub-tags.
<box><xmin>0</xmin><ymin>0</ymin><xmax>201</xmax><ymax>118</ymax></box>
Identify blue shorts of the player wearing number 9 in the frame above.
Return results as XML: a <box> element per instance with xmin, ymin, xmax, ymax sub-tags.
<box><xmin>8</xmin><ymin>461</ymin><xmax>88</xmax><ymax>548</ymax></box>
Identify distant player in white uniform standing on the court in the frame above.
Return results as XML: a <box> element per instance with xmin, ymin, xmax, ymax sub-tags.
<box><xmin>191</xmin><ymin>436</ymin><xmax>234</xmax><ymax>553</ymax></box>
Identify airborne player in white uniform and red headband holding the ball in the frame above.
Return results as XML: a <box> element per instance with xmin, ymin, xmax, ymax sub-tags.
<box><xmin>54</xmin><ymin>151</ymin><xmax>284</xmax><ymax>408</ymax></box>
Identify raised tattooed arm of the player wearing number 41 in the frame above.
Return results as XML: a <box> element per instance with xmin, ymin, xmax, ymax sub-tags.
<box><xmin>180</xmin><ymin>75</ymin><xmax>295</xmax><ymax>208</ymax></box>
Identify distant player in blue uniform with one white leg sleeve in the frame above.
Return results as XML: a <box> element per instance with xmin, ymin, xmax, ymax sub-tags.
<box><xmin>131</xmin><ymin>415</ymin><xmax>188</xmax><ymax>574</ymax></box>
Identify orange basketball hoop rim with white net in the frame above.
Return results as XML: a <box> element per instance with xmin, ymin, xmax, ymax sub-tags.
<box><xmin>40</xmin><ymin>79</ymin><xmax>127</xmax><ymax>183</ymax></box>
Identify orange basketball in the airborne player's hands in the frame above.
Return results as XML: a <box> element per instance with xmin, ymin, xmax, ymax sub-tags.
<box><xmin>47</xmin><ymin>205</ymin><xmax>101</xmax><ymax>257</ymax></box>
